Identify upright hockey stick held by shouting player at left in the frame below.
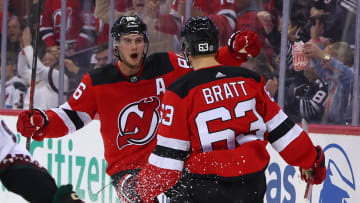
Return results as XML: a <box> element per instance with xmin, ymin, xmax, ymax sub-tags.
<box><xmin>26</xmin><ymin>0</ymin><xmax>43</xmax><ymax>151</ymax></box>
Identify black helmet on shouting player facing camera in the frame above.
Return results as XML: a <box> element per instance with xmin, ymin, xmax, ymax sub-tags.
<box><xmin>111</xmin><ymin>15</ymin><xmax>149</xmax><ymax>42</ymax></box>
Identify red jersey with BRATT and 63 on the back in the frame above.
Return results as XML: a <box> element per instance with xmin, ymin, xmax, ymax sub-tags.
<box><xmin>137</xmin><ymin>66</ymin><xmax>316</xmax><ymax>200</ymax></box>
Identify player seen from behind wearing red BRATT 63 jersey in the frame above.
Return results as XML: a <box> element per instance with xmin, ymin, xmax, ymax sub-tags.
<box><xmin>119</xmin><ymin>17</ymin><xmax>326</xmax><ymax>203</ymax></box>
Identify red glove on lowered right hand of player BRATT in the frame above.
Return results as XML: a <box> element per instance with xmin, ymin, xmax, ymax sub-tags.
<box><xmin>300</xmin><ymin>146</ymin><xmax>326</xmax><ymax>184</ymax></box>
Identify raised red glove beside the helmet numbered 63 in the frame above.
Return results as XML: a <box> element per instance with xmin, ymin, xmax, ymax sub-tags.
<box><xmin>228</xmin><ymin>30</ymin><xmax>262</xmax><ymax>60</ymax></box>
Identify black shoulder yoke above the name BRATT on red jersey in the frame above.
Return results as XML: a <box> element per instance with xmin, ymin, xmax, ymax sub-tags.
<box><xmin>168</xmin><ymin>66</ymin><xmax>261</xmax><ymax>98</ymax></box>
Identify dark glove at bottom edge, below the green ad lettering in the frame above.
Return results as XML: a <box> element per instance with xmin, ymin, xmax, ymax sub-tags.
<box><xmin>52</xmin><ymin>184</ymin><xmax>85</xmax><ymax>203</ymax></box>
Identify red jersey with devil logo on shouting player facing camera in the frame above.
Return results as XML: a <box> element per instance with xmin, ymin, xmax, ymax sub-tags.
<box><xmin>41</xmin><ymin>52</ymin><xmax>191</xmax><ymax>175</ymax></box>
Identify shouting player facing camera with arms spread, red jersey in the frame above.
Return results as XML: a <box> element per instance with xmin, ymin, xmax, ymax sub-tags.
<box><xmin>17</xmin><ymin>16</ymin><xmax>257</xmax><ymax>201</ymax></box>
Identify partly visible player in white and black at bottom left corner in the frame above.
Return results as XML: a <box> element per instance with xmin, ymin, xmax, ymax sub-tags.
<box><xmin>0</xmin><ymin>117</ymin><xmax>83</xmax><ymax>203</ymax></box>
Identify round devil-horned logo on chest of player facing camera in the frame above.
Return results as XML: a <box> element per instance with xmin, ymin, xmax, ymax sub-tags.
<box><xmin>116</xmin><ymin>97</ymin><xmax>160</xmax><ymax>149</ymax></box>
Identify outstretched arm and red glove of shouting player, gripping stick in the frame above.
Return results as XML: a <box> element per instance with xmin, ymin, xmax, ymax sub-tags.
<box><xmin>17</xmin><ymin>74</ymin><xmax>97</xmax><ymax>141</ymax></box>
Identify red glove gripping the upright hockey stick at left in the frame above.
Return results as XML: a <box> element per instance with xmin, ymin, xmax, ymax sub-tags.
<box><xmin>16</xmin><ymin>109</ymin><xmax>49</xmax><ymax>141</ymax></box>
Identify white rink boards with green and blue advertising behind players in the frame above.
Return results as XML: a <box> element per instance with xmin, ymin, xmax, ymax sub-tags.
<box><xmin>0</xmin><ymin>111</ymin><xmax>360</xmax><ymax>203</ymax></box>
